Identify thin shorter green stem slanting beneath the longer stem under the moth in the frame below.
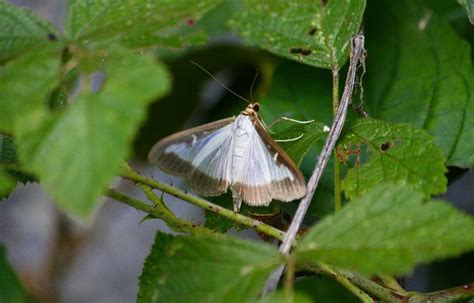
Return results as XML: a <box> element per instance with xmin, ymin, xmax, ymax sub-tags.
<box><xmin>106</xmin><ymin>189</ymin><xmax>214</xmax><ymax>235</ymax></box>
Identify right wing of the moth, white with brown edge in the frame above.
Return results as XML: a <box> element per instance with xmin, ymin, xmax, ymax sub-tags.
<box><xmin>232</xmin><ymin>120</ymin><xmax>306</xmax><ymax>206</ymax></box>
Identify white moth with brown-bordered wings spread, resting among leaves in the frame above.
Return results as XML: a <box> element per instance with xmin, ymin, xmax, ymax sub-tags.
<box><xmin>148</xmin><ymin>103</ymin><xmax>306</xmax><ymax>212</ymax></box>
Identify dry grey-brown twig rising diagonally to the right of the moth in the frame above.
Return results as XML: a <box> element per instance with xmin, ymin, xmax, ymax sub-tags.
<box><xmin>263</xmin><ymin>35</ymin><xmax>364</xmax><ymax>294</ymax></box>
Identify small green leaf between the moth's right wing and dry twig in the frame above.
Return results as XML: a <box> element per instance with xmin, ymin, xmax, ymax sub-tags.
<box><xmin>273</xmin><ymin>121</ymin><xmax>329</xmax><ymax>166</ymax></box>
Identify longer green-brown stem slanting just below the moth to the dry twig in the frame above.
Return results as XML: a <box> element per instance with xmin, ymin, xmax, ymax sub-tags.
<box><xmin>121</xmin><ymin>165</ymin><xmax>284</xmax><ymax>241</ymax></box>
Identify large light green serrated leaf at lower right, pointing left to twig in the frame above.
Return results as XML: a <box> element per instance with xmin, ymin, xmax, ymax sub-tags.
<box><xmin>295</xmin><ymin>184</ymin><xmax>474</xmax><ymax>274</ymax></box>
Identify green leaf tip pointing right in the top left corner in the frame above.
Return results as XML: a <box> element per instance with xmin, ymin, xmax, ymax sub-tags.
<box><xmin>0</xmin><ymin>0</ymin><xmax>60</xmax><ymax>61</ymax></box>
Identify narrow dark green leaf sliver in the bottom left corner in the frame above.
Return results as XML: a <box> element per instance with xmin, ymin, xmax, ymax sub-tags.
<box><xmin>0</xmin><ymin>246</ymin><xmax>31</xmax><ymax>303</ymax></box>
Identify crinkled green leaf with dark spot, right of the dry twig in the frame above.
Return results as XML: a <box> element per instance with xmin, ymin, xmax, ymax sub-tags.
<box><xmin>338</xmin><ymin>118</ymin><xmax>447</xmax><ymax>199</ymax></box>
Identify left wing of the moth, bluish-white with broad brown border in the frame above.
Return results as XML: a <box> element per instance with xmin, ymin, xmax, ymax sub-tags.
<box><xmin>148</xmin><ymin>117</ymin><xmax>235</xmax><ymax>196</ymax></box>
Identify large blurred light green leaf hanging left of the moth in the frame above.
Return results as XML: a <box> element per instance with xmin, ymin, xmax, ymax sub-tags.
<box><xmin>16</xmin><ymin>47</ymin><xmax>170</xmax><ymax>218</ymax></box>
